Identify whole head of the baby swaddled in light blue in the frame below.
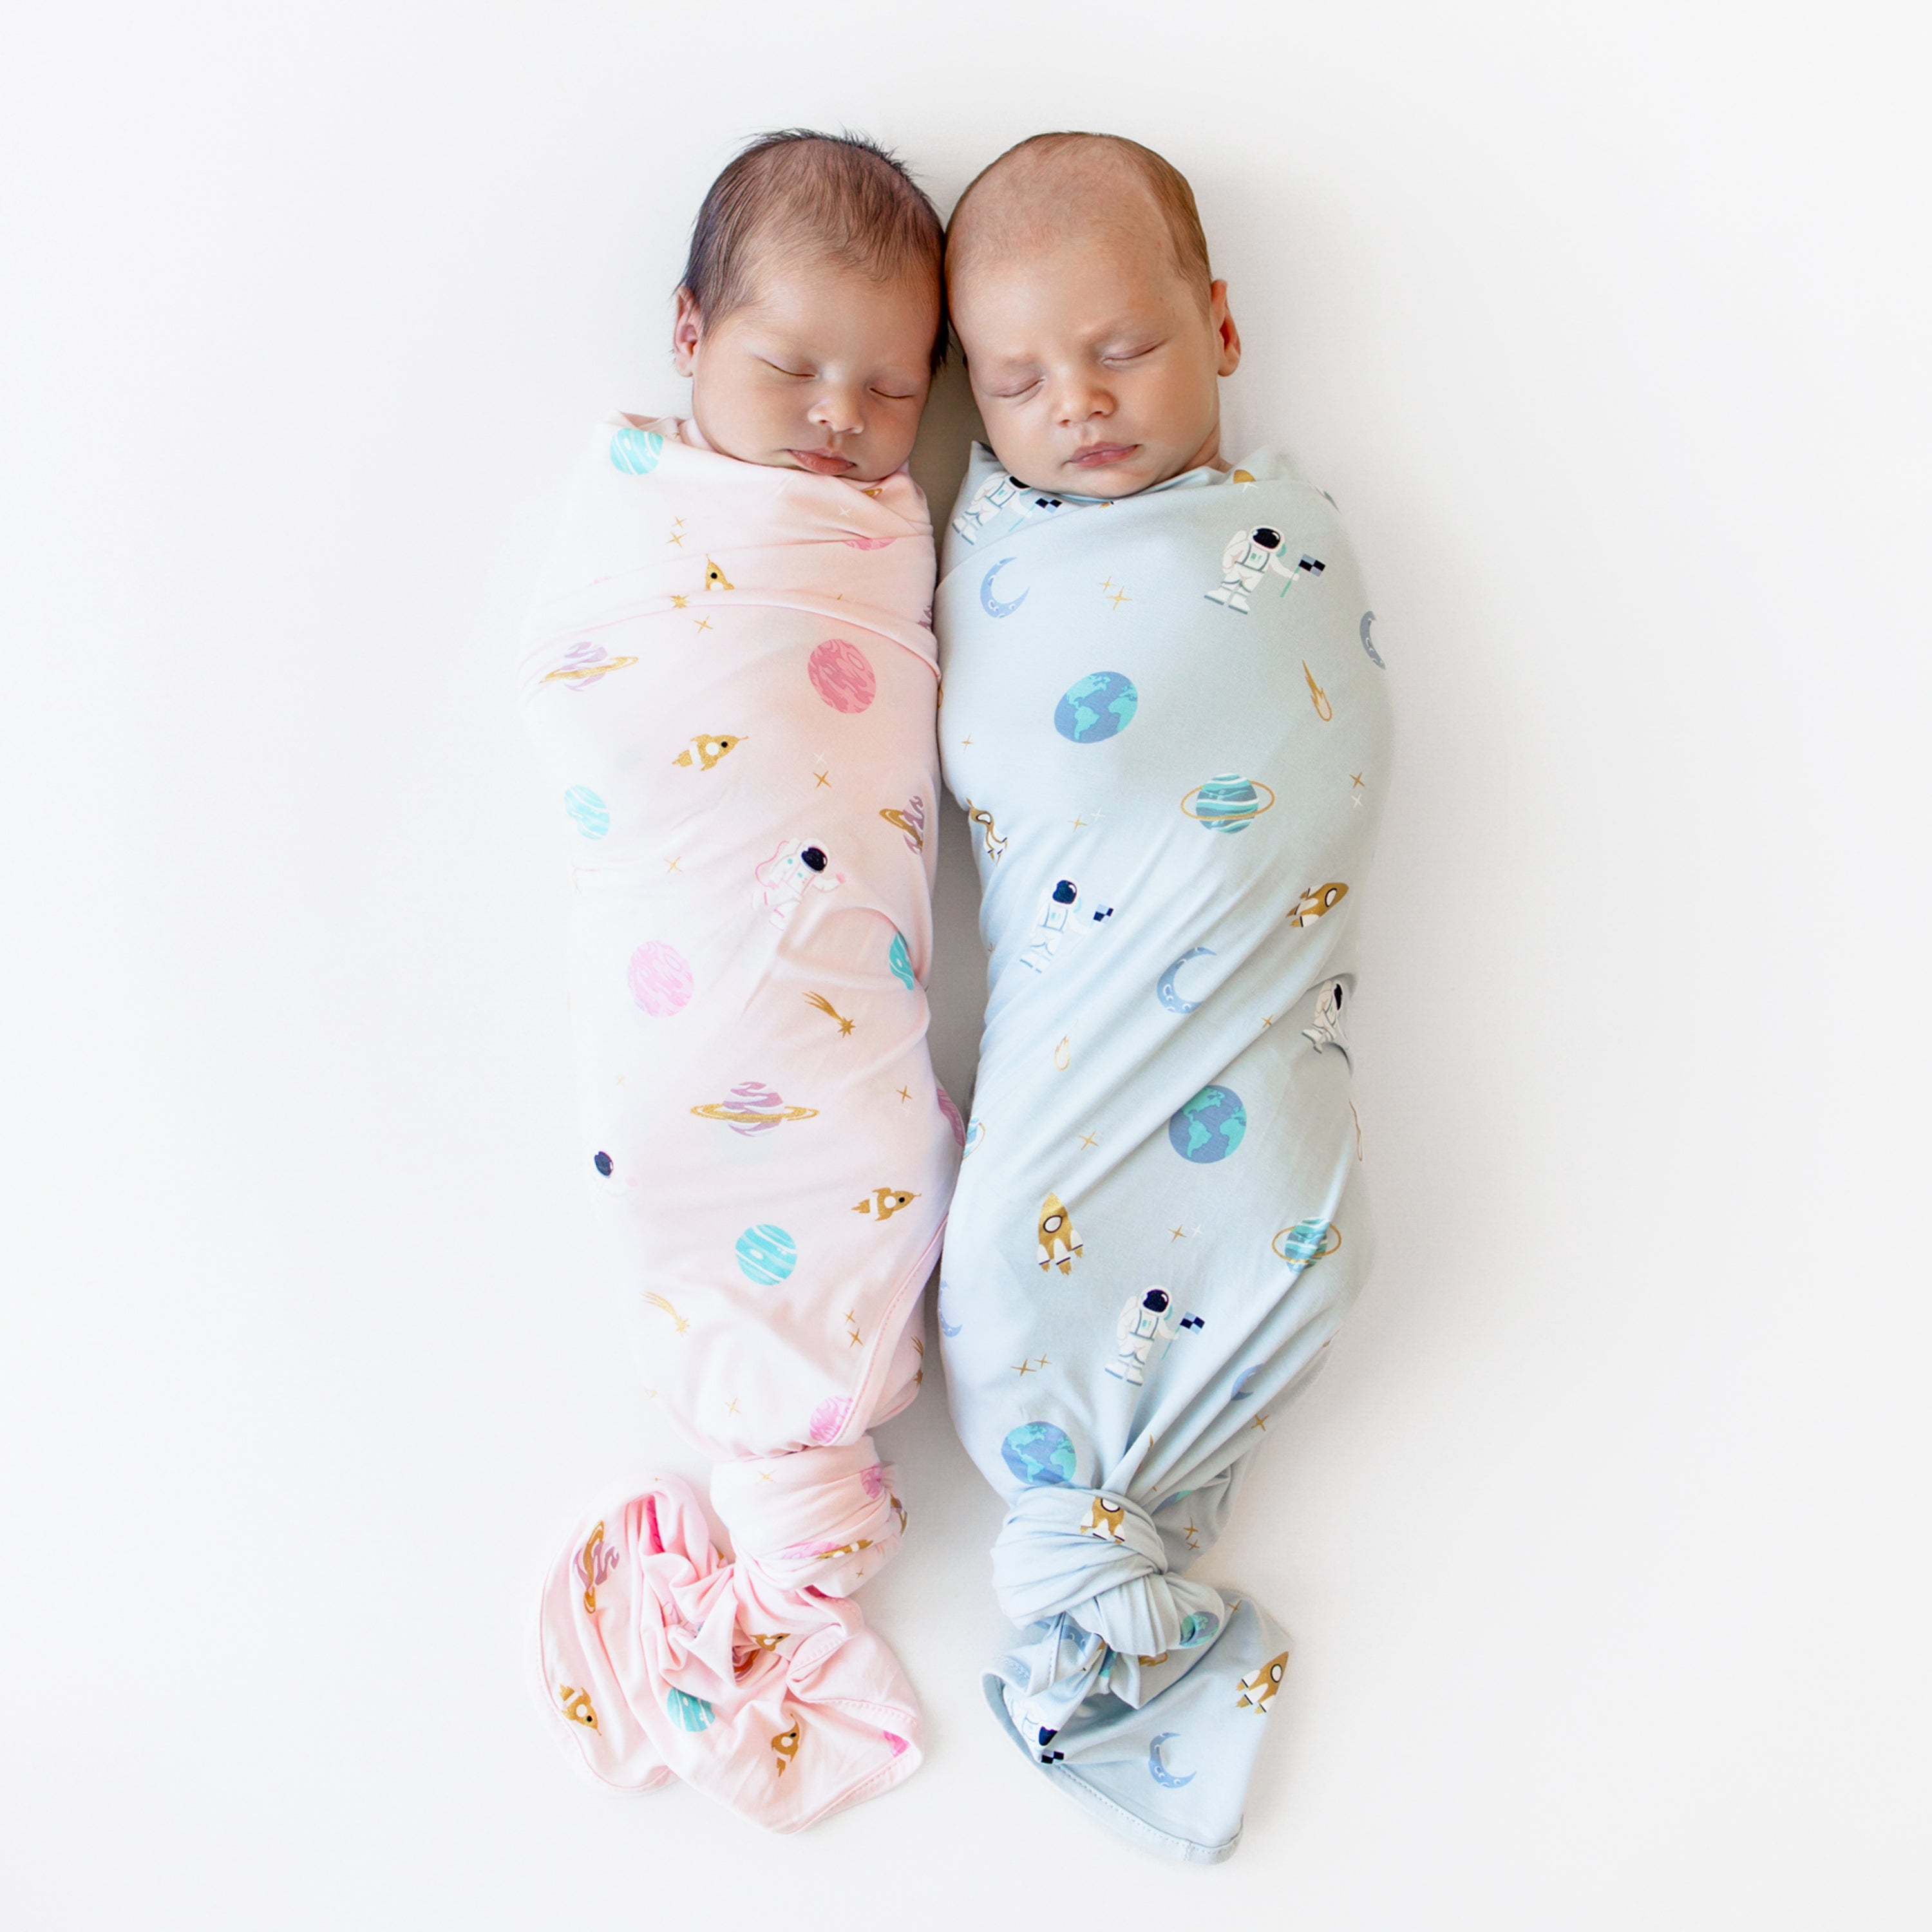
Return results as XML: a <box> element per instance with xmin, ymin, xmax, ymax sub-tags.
<box><xmin>947</xmin><ymin>133</ymin><xmax>1240</xmax><ymax>497</ymax></box>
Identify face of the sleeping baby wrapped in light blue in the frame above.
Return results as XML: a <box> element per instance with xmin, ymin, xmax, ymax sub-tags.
<box><xmin>949</xmin><ymin>224</ymin><xmax>1240</xmax><ymax>497</ymax></box>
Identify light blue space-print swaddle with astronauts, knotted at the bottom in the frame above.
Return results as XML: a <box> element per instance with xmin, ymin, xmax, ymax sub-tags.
<box><xmin>935</xmin><ymin>448</ymin><xmax>1389</xmax><ymax>1861</ymax></box>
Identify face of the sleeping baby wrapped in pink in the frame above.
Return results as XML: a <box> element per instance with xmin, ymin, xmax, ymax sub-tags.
<box><xmin>672</xmin><ymin>259</ymin><xmax>939</xmax><ymax>483</ymax></box>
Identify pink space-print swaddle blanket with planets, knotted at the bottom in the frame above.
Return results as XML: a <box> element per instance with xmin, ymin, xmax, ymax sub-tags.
<box><xmin>520</xmin><ymin>417</ymin><xmax>962</xmax><ymax>1830</ymax></box>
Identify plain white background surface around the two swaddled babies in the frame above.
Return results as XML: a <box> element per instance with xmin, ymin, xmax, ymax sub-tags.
<box><xmin>0</xmin><ymin>0</ymin><xmax>1932</xmax><ymax>1932</ymax></box>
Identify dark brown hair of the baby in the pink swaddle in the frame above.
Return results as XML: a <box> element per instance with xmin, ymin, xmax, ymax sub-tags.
<box><xmin>682</xmin><ymin>128</ymin><xmax>947</xmax><ymax>369</ymax></box>
